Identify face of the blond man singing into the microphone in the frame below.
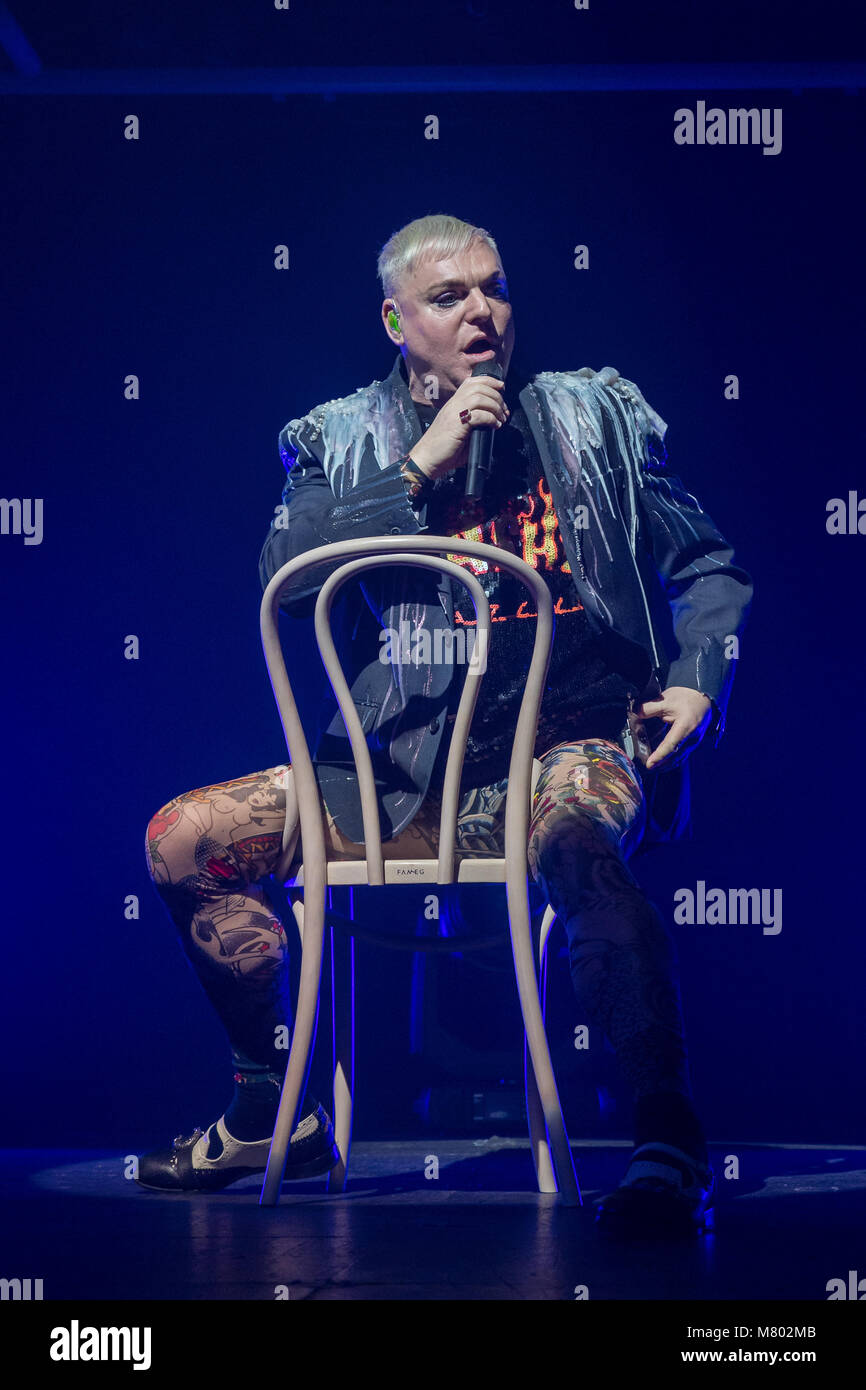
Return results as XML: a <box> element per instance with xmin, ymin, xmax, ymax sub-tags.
<box><xmin>382</xmin><ymin>242</ymin><xmax>514</xmax><ymax>400</ymax></box>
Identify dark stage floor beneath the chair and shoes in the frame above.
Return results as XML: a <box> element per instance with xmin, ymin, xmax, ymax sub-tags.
<box><xmin>0</xmin><ymin>1138</ymin><xmax>866</xmax><ymax>1301</ymax></box>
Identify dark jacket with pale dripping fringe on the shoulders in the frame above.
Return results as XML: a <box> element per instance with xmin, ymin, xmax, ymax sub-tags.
<box><xmin>259</xmin><ymin>356</ymin><xmax>752</xmax><ymax>847</ymax></box>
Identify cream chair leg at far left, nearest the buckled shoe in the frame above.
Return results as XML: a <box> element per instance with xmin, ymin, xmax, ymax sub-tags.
<box><xmin>259</xmin><ymin>899</ymin><xmax>325</xmax><ymax>1207</ymax></box>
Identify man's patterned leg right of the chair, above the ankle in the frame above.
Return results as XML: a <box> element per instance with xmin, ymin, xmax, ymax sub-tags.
<box><xmin>528</xmin><ymin>739</ymin><xmax>689</xmax><ymax>1098</ymax></box>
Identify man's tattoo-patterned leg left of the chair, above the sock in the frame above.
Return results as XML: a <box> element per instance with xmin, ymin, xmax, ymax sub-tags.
<box><xmin>146</xmin><ymin>765</ymin><xmax>297</xmax><ymax>1066</ymax></box>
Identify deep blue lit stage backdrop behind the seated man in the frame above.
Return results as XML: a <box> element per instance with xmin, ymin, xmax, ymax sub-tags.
<box><xmin>0</xmin><ymin>43</ymin><xmax>866</xmax><ymax>1151</ymax></box>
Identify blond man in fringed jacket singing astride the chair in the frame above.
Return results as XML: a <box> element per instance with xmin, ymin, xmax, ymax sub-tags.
<box><xmin>139</xmin><ymin>215</ymin><xmax>752</xmax><ymax>1234</ymax></box>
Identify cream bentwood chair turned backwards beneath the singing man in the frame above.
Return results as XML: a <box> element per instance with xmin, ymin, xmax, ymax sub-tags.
<box><xmin>260</xmin><ymin>535</ymin><xmax>581</xmax><ymax>1207</ymax></box>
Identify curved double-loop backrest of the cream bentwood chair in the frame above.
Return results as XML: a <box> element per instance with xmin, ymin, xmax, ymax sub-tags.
<box><xmin>261</xmin><ymin>534</ymin><xmax>553</xmax><ymax>891</ymax></box>
